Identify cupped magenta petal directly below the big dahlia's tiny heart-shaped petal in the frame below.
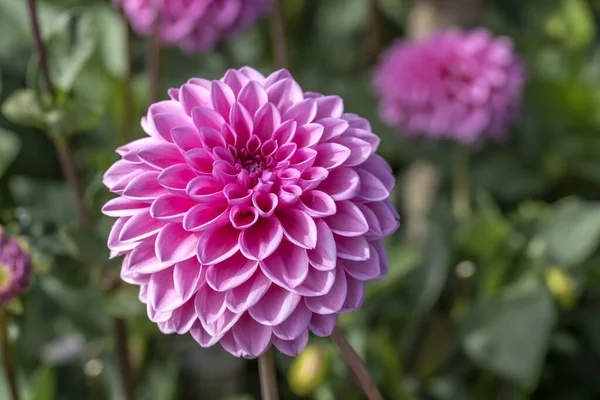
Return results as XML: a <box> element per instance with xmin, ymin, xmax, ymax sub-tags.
<box><xmin>236</xmin><ymin>216</ymin><xmax>283</xmax><ymax>260</ymax></box>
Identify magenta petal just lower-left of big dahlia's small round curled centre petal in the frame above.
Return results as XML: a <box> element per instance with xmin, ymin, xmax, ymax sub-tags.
<box><xmin>197</xmin><ymin>225</ymin><xmax>240</xmax><ymax>265</ymax></box>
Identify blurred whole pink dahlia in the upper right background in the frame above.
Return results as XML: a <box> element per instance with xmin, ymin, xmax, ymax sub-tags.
<box><xmin>374</xmin><ymin>29</ymin><xmax>525</xmax><ymax>144</ymax></box>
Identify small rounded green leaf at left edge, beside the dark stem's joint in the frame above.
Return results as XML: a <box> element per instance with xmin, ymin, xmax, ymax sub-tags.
<box><xmin>2</xmin><ymin>89</ymin><xmax>44</xmax><ymax>128</ymax></box>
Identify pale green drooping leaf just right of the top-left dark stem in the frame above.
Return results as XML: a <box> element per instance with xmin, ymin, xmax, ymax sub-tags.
<box><xmin>47</xmin><ymin>11</ymin><xmax>98</xmax><ymax>92</ymax></box>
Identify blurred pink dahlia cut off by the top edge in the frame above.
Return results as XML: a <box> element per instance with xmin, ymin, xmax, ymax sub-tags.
<box><xmin>113</xmin><ymin>0</ymin><xmax>269</xmax><ymax>52</ymax></box>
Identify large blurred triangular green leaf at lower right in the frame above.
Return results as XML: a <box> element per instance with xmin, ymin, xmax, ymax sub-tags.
<box><xmin>459</xmin><ymin>276</ymin><xmax>556</xmax><ymax>388</ymax></box>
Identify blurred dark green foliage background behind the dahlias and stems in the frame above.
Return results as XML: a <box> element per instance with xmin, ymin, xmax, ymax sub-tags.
<box><xmin>0</xmin><ymin>0</ymin><xmax>600</xmax><ymax>400</ymax></box>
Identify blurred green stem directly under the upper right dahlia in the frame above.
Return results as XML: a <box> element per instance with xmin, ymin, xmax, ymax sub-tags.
<box><xmin>452</xmin><ymin>145</ymin><xmax>471</xmax><ymax>219</ymax></box>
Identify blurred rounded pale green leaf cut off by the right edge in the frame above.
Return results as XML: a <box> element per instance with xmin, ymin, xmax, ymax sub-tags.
<box><xmin>541</xmin><ymin>197</ymin><xmax>600</xmax><ymax>266</ymax></box>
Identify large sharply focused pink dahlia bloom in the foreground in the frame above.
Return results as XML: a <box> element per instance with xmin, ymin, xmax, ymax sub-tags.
<box><xmin>103</xmin><ymin>67</ymin><xmax>398</xmax><ymax>358</ymax></box>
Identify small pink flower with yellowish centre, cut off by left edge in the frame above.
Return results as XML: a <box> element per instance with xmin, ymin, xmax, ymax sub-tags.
<box><xmin>0</xmin><ymin>227</ymin><xmax>31</xmax><ymax>306</ymax></box>
